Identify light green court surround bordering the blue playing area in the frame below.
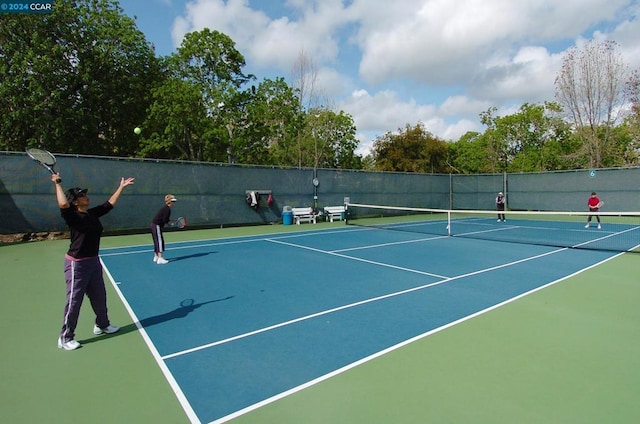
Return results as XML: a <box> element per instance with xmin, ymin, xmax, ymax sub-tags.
<box><xmin>0</xmin><ymin>225</ymin><xmax>640</xmax><ymax>423</ymax></box>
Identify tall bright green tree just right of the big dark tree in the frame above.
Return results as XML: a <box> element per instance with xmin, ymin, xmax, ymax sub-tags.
<box><xmin>144</xmin><ymin>28</ymin><xmax>255</xmax><ymax>162</ymax></box>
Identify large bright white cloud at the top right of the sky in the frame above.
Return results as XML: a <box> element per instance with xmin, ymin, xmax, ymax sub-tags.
<box><xmin>360</xmin><ymin>0</ymin><xmax>628</xmax><ymax>84</ymax></box>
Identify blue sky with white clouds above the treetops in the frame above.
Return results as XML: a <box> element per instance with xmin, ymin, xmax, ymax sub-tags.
<box><xmin>120</xmin><ymin>0</ymin><xmax>640</xmax><ymax>154</ymax></box>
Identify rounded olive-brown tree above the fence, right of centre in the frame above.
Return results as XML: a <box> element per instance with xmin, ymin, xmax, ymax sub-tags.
<box><xmin>373</xmin><ymin>123</ymin><xmax>450</xmax><ymax>173</ymax></box>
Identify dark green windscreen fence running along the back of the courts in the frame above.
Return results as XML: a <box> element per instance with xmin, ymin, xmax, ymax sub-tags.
<box><xmin>0</xmin><ymin>152</ymin><xmax>640</xmax><ymax>234</ymax></box>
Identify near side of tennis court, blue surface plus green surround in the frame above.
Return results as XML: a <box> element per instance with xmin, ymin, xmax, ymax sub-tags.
<box><xmin>0</xmin><ymin>223</ymin><xmax>640</xmax><ymax>423</ymax></box>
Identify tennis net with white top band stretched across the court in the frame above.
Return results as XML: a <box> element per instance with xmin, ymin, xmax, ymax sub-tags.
<box><xmin>346</xmin><ymin>203</ymin><xmax>640</xmax><ymax>253</ymax></box>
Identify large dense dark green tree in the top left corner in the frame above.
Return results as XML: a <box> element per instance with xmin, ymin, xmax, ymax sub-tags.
<box><xmin>0</xmin><ymin>0</ymin><xmax>159</xmax><ymax>156</ymax></box>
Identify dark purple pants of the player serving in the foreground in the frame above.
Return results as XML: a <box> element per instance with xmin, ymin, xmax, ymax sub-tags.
<box><xmin>60</xmin><ymin>256</ymin><xmax>109</xmax><ymax>341</ymax></box>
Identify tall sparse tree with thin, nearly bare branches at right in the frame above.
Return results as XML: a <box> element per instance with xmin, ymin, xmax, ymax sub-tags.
<box><xmin>555</xmin><ymin>40</ymin><xmax>630</xmax><ymax>167</ymax></box>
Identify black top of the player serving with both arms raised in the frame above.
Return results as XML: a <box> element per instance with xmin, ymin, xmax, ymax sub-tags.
<box><xmin>60</xmin><ymin>202</ymin><xmax>113</xmax><ymax>259</ymax></box>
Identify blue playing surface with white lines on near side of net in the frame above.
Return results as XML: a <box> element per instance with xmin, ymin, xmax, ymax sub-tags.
<box><xmin>101</xmin><ymin>226</ymin><xmax>616</xmax><ymax>422</ymax></box>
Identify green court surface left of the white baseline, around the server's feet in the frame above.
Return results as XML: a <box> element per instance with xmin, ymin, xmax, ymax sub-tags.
<box><xmin>0</xmin><ymin>240</ymin><xmax>189</xmax><ymax>424</ymax></box>
